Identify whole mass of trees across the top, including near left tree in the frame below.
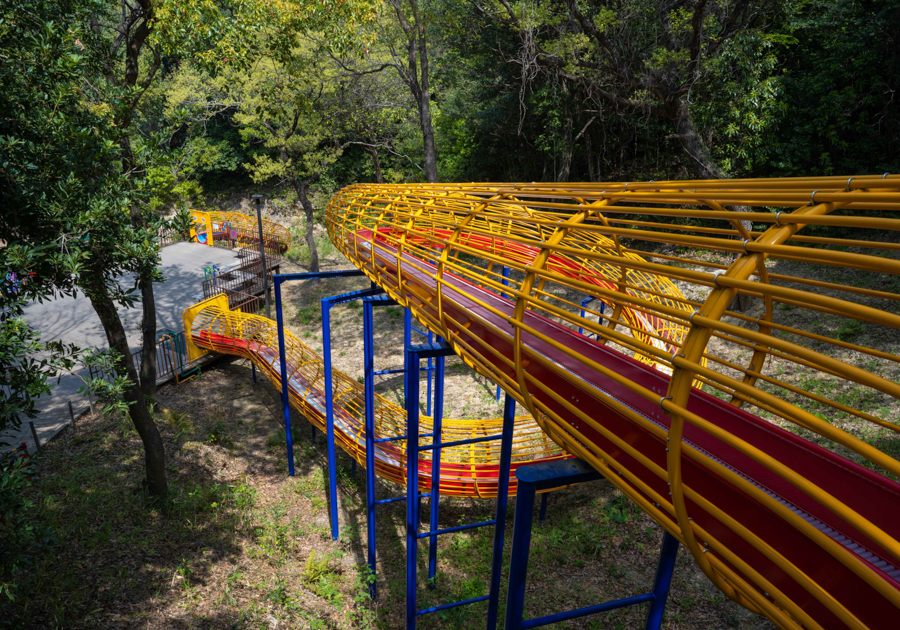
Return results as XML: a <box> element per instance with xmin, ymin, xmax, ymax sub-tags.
<box><xmin>0</xmin><ymin>0</ymin><xmax>900</xmax><ymax>504</ymax></box>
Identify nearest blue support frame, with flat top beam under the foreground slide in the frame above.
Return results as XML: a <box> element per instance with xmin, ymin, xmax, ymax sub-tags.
<box><xmin>504</xmin><ymin>459</ymin><xmax>678</xmax><ymax>630</ymax></box>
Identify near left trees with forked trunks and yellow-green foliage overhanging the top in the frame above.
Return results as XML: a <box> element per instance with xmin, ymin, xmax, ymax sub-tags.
<box><xmin>0</xmin><ymin>0</ymin><xmax>380</xmax><ymax>498</ymax></box>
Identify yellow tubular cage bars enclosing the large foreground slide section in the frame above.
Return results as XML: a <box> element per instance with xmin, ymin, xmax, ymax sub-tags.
<box><xmin>326</xmin><ymin>175</ymin><xmax>900</xmax><ymax>628</ymax></box>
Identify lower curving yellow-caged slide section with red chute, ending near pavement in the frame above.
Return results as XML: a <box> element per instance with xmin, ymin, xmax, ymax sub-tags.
<box><xmin>184</xmin><ymin>295</ymin><xmax>569</xmax><ymax>499</ymax></box>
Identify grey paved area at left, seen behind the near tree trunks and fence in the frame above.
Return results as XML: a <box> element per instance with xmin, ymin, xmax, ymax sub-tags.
<box><xmin>0</xmin><ymin>243</ymin><xmax>237</xmax><ymax>452</ymax></box>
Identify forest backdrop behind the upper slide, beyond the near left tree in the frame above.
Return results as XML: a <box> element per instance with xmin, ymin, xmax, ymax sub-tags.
<box><xmin>151</xmin><ymin>0</ymin><xmax>900</xmax><ymax>209</ymax></box>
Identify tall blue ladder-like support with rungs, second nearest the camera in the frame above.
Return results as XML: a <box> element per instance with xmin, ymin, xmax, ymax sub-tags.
<box><xmin>405</xmin><ymin>342</ymin><xmax>515</xmax><ymax>630</ymax></box>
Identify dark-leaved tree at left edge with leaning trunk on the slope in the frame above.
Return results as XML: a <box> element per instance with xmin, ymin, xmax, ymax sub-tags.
<box><xmin>0</xmin><ymin>0</ymin><xmax>167</xmax><ymax>497</ymax></box>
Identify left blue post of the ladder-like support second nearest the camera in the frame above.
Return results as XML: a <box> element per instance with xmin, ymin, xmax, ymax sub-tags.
<box><xmin>404</xmin><ymin>348</ymin><xmax>419</xmax><ymax>630</ymax></box>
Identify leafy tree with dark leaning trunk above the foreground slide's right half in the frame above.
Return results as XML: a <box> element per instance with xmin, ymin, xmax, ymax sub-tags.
<box><xmin>473</xmin><ymin>0</ymin><xmax>790</xmax><ymax>179</ymax></box>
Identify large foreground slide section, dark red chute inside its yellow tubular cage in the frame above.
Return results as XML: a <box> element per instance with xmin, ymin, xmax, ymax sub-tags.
<box><xmin>326</xmin><ymin>178</ymin><xmax>900</xmax><ymax>628</ymax></box>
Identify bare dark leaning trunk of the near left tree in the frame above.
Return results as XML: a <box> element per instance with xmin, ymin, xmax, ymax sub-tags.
<box><xmin>88</xmin><ymin>286</ymin><xmax>169</xmax><ymax>499</ymax></box>
